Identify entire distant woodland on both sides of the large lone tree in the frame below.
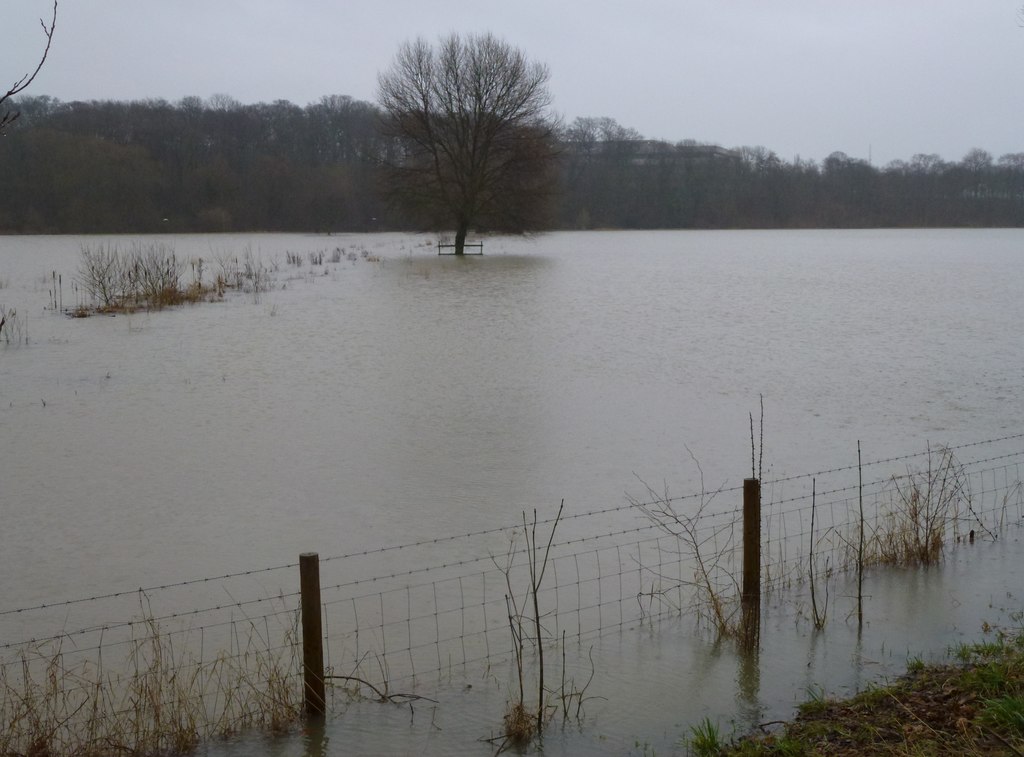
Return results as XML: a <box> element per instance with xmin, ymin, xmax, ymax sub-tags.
<box><xmin>0</xmin><ymin>95</ymin><xmax>1024</xmax><ymax>234</ymax></box>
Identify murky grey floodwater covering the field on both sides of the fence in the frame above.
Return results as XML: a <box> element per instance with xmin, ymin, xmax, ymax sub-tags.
<box><xmin>0</xmin><ymin>229</ymin><xmax>1024</xmax><ymax>755</ymax></box>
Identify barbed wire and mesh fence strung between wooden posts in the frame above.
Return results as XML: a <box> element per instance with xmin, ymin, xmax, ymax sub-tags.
<box><xmin>0</xmin><ymin>434</ymin><xmax>1024</xmax><ymax>753</ymax></box>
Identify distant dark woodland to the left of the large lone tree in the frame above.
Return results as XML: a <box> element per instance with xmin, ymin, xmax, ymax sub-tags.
<box><xmin>0</xmin><ymin>95</ymin><xmax>393</xmax><ymax>233</ymax></box>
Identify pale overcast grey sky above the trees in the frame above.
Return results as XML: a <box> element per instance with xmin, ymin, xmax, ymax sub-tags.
<box><xmin>6</xmin><ymin>0</ymin><xmax>1024</xmax><ymax>166</ymax></box>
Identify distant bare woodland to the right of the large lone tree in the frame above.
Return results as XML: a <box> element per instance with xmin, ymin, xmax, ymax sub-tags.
<box><xmin>559</xmin><ymin>118</ymin><xmax>1024</xmax><ymax>228</ymax></box>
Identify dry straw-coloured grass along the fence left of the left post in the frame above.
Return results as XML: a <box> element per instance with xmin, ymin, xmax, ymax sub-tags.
<box><xmin>0</xmin><ymin>598</ymin><xmax>302</xmax><ymax>757</ymax></box>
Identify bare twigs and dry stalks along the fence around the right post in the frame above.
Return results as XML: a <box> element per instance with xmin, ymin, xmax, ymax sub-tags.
<box><xmin>627</xmin><ymin>434</ymin><xmax>1024</xmax><ymax>639</ymax></box>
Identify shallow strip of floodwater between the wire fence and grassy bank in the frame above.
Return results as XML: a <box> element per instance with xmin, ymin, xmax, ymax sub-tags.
<box><xmin>204</xmin><ymin>535</ymin><xmax>1024</xmax><ymax>757</ymax></box>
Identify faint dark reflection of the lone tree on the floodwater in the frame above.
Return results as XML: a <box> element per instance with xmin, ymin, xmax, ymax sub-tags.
<box><xmin>362</xmin><ymin>255</ymin><xmax>559</xmax><ymax>530</ymax></box>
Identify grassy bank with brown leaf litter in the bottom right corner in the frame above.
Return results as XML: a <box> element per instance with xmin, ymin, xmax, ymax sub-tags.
<box><xmin>688</xmin><ymin>632</ymin><xmax>1024</xmax><ymax>757</ymax></box>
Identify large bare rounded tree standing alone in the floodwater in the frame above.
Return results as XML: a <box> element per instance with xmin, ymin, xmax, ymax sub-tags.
<box><xmin>378</xmin><ymin>34</ymin><xmax>555</xmax><ymax>255</ymax></box>
